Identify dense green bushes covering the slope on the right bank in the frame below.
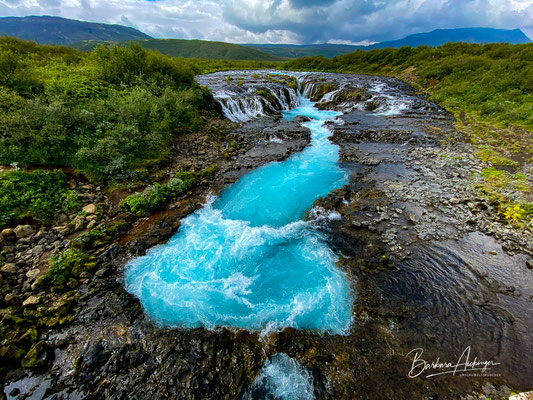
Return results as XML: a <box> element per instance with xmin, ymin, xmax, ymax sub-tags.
<box><xmin>285</xmin><ymin>43</ymin><xmax>533</xmax><ymax>128</ymax></box>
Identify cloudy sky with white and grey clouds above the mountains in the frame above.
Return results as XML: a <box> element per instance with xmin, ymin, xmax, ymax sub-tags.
<box><xmin>0</xmin><ymin>0</ymin><xmax>533</xmax><ymax>44</ymax></box>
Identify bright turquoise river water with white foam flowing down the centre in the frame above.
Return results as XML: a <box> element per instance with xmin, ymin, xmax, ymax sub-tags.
<box><xmin>125</xmin><ymin>99</ymin><xmax>353</xmax><ymax>334</ymax></box>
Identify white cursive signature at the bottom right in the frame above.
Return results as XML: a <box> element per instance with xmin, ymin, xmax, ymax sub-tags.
<box><xmin>406</xmin><ymin>346</ymin><xmax>500</xmax><ymax>378</ymax></box>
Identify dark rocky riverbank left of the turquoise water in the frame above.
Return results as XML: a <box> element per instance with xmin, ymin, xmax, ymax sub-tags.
<box><xmin>0</xmin><ymin>108</ymin><xmax>310</xmax><ymax>398</ymax></box>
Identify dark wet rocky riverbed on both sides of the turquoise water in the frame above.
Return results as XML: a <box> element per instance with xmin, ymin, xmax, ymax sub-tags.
<box><xmin>0</xmin><ymin>72</ymin><xmax>533</xmax><ymax>399</ymax></box>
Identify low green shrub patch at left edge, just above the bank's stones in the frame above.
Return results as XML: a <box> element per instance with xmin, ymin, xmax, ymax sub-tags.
<box><xmin>0</xmin><ymin>169</ymin><xmax>79</xmax><ymax>226</ymax></box>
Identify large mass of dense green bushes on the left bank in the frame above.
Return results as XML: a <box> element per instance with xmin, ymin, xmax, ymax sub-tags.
<box><xmin>0</xmin><ymin>37</ymin><xmax>210</xmax><ymax>183</ymax></box>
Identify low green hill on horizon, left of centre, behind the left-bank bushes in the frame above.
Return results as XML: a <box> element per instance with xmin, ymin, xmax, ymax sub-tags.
<box><xmin>72</xmin><ymin>39</ymin><xmax>283</xmax><ymax>61</ymax></box>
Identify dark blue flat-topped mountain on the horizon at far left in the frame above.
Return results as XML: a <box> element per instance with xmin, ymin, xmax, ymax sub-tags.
<box><xmin>0</xmin><ymin>16</ymin><xmax>151</xmax><ymax>45</ymax></box>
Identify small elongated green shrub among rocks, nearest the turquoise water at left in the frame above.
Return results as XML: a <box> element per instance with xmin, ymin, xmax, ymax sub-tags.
<box><xmin>119</xmin><ymin>172</ymin><xmax>197</xmax><ymax>217</ymax></box>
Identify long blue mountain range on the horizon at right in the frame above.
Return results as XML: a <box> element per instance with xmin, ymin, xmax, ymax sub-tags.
<box><xmin>243</xmin><ymin>28</ymin><xmax>531</xmax><ymax>58</ymax></box>
